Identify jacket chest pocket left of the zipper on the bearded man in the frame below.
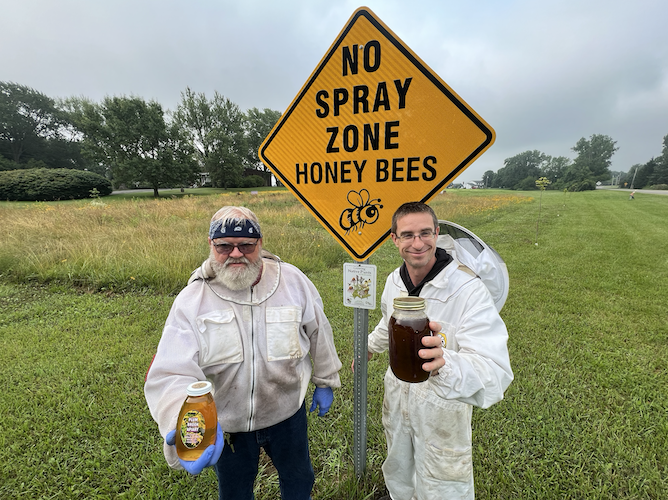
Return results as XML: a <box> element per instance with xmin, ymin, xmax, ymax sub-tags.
<box><xmin>197</xmin><ymin>309</ymin><xmax>244</xmax><ymax>368</ymax></box>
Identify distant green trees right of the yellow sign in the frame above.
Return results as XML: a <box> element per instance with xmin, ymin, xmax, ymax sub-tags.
<box><xmin>482</xmin><ymin>134</ymin><xmax>668</xmax><ymax>191</ymax></box>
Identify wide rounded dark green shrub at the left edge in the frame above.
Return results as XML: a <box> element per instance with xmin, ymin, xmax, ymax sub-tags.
<box><xmin>0</xmin><ymin>168</ymin><xmax>112</xmax><ymax>201</ymax></box>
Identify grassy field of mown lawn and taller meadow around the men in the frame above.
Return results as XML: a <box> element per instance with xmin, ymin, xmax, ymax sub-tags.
<box><xmin>0</xmin><ymin>190</ymin><xmax>668</xmax><ymax>500</ymax></box>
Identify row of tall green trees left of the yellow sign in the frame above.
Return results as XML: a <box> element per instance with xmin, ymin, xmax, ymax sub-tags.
<box><xmin>0</xmin><ymin>82</ymin><xmax>281</xmax><ymax>196</ymax></box>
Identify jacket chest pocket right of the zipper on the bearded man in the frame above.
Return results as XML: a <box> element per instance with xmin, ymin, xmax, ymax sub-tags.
<box><xmin>266</xmin><ymin>307</ymin><xmax>303</xmax><ymax>361</ymax></box>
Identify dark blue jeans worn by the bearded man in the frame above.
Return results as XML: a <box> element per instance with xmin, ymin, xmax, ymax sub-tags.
<box><xmin>214</xmin><ymin>403</ymin><xmax>315</xmax><ymax>500</ymax></box>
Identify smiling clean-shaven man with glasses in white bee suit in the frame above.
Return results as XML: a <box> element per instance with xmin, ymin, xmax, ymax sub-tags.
<box><xmin>368</xmin><ymin>202</ymin><xmax>513</xmax><ymax>500</ymax></box>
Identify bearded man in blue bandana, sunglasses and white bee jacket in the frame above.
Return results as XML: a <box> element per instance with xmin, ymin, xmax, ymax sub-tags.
<box><xmin>144</xmin><ymin>207</ymin><xmax>341</xmax><ymax>500</ymax></box>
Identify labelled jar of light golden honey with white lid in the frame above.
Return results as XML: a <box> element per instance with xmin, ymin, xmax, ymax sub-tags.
<box><xmin>176</xmin><ymin>381</ymin><xmax>218</xmax><ymax>461</ymax></box>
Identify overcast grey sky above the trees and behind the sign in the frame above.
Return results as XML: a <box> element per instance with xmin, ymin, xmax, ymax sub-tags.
<box><xmin>0</xmin><ymin>0</ymin><xmax>668</xmax><ymax>181</ymax></box>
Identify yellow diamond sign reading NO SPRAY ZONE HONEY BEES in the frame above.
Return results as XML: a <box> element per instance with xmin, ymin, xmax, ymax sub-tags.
<box><xmin>260</xmin><ymin>7</ymin><xmax>495</xmax><ymax>260</ymax></box>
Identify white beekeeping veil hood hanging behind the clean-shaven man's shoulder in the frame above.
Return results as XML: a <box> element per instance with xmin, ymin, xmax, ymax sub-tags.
<box><xmin>436</xmin><ymin>220</ymin><xmax>509</xmax><ymax>311</ymax></box>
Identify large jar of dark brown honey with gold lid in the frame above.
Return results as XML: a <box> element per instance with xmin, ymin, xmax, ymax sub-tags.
<box><xmin>388</xmin><ymin>297</ymin><xmax>431</xmax><ymax>382</ymax></box>
